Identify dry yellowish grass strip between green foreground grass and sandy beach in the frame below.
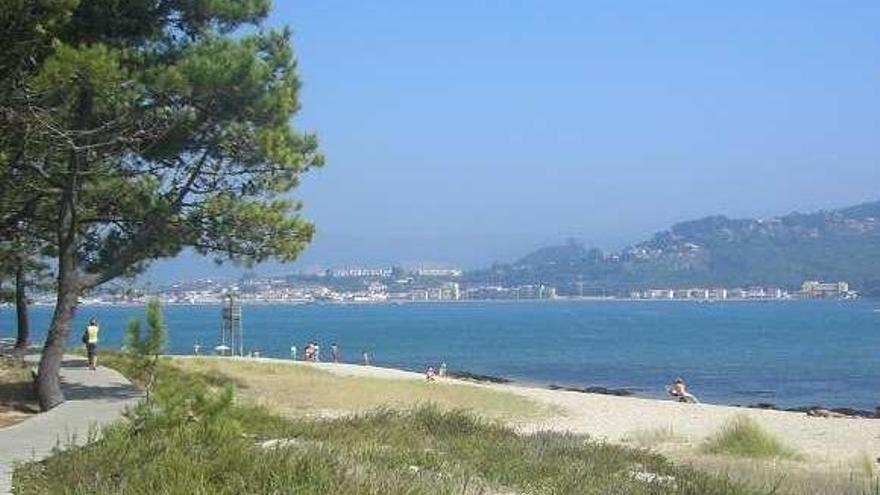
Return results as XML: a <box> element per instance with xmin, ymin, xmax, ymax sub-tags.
<box><xmin>174</xmin><ymin>358</ymin><xmax>548</xmax><ymax>420</ymax></box>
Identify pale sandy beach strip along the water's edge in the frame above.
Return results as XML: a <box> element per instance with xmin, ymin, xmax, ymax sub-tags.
<box><xmin>276</xmin><ymin>358</ymin><xmax>880</xmax><ymax>466</ymax></box>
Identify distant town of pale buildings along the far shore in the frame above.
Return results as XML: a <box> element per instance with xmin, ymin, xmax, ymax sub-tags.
<box><xmin>20</xmin><ymin>267</ymin><xmax>858</xmax><ymax>305</ymax></box>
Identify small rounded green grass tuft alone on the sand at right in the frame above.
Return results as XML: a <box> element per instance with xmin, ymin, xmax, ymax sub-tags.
<box><xmin>701</xmin><ymin>415</ymin><xmax>801</xmax><ymax>460</ymax></box>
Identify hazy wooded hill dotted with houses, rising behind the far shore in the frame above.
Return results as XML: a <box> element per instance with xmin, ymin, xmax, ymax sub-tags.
<box><xmin>468</xmin><ymin>201</ymin><xmax>880</xmax><ymax>296</ymax></box>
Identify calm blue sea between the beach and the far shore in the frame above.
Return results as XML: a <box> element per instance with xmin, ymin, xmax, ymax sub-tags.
<box><xmin>0</xmin><ymin>301</ymin><xmax>880</xmax><ymax>409</ymax></box>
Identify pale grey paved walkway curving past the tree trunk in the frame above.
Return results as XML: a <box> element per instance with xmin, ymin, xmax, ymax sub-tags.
<box><xmin>0</xmin><ymin>356</ymin><xmax>141</xmax><ymax>494</ymax></box>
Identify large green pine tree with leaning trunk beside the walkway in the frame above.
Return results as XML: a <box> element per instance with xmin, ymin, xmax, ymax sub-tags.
<box><xmin>0</xmin><ymin>0</ymin><xmax>323</xmax><ymax>407</ymax></box>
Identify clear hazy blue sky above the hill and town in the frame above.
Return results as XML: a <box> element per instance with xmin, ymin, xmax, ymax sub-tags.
<box><xmin>144</xmin><ymin>0</ymin><xmax>880</xmax><ymax>282</ymax></box>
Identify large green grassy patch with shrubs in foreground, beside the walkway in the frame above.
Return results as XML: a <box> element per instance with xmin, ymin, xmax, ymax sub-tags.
<box><xmin>13</xmin><ymin>350</ymin><xmax>755</xmax><ymax>495</ymax></box>
